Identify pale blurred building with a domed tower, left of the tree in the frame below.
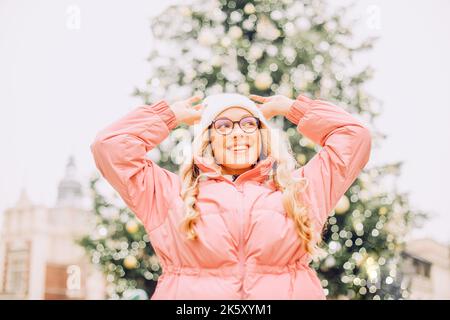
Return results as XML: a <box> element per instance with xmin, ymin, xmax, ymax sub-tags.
<box><xmin>0</xmin><ymin>158</ymin><xmax>105</xmax><ymax>299</ymax></box>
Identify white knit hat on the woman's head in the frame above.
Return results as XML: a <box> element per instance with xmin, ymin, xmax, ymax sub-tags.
<box><xmin>198</xmin><ymin>93</ymin><xmax>270</xmax><ymax>132</ymax></box>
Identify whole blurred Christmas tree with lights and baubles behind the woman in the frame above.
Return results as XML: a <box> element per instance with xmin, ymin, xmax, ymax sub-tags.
<box><xmin>83</xmin><ymin>0</ymin><xmax>423</xmax><ymax>299</ymax></box>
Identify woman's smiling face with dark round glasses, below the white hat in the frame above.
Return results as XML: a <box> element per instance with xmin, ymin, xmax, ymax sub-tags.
<box><xmin>210</xmin><ymin>107</ymin><xmax>261</xmax><ymax>174</ymax></box>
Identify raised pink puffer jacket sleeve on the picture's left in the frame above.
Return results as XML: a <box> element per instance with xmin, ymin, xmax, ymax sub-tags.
<box><xmin>90</xmin><ymin>100</ymin><xmax>181</xmax><ymax>230</ymax></box>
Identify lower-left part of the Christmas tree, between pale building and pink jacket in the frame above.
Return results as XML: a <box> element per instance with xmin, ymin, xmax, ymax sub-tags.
<box><xmin>79</xmin><ymin>176</ymin><xmax>161</xmax><ymax>299</ymax></box>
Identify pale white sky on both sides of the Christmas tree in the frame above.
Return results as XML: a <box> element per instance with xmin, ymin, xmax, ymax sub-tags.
<box><xmin>0</xmin><ymin>0</ymin><xmax>450</xmax><ymax>242</ymax></box>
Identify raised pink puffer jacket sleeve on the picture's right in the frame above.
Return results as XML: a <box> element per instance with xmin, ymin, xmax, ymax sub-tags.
<box><xmin>286</xmin><ymin>95</ymin><xmax>372</xmax><ymax>231</ymax></box>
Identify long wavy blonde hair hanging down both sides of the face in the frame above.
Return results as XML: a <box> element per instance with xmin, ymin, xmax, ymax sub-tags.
<box><xmin>180</xmin><ymin>124</ymin><xmax>321</xmax><ymax>255</ymax></box>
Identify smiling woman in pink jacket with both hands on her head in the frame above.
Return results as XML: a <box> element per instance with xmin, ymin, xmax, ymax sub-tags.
<box><xmin>91</xmin><ymin>93</ymin><xmax>371</xmax><ymax>299</ymax></box>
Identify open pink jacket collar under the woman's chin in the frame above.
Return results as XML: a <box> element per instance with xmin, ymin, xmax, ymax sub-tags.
<box><xmin>194</xmin><ymin>155</ymin><xmax>276</xmax><ymax>183</ymax></box>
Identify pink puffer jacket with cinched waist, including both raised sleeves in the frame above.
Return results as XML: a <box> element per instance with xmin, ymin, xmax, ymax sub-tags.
<box><xmin>91</xmin><ymin>95</ymin><xmax>371</xmax><ymax>299</ymax></box>
